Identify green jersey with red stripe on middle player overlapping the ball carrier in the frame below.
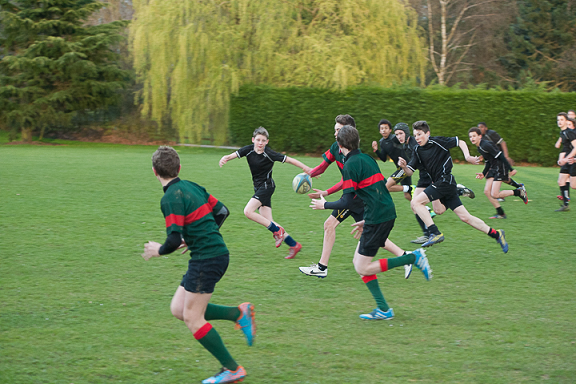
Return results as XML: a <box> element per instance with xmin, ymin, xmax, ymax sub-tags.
<box><xmin>342</xmin><ymin>149</ymin><xmax>396</xmax><ymax>224</ymax></box>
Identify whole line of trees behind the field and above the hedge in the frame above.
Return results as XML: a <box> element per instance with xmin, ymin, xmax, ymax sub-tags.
<box><xmin>0</xmin><ymin>0</ymin><xmax>576</xmax><ymax>144</ymax></box>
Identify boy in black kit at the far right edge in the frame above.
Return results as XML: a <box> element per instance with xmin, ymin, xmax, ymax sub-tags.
<box><xmin>556</xmin><ymin>112</ymin><xmax>576</xmax><ymax>212</ymax></box>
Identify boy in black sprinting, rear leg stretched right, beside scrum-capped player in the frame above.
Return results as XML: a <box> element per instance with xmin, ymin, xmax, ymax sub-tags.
<box><xmin>399</xmin><ymin>121</ymin><xmax>508</xmax><ymax>253</ymax></box>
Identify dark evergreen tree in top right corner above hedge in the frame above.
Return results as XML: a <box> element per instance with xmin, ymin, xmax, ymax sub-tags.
<box><xmin>500</xmin><ymin>0</ymin><xmax>576</xmax><ymax>90</ymax></box>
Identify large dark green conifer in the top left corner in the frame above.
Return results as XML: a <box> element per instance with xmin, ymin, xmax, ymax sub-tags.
<box><xmin>0</xmin><ymin>0</ymin><xmax>130</xmax><ymax>141</ymax></box>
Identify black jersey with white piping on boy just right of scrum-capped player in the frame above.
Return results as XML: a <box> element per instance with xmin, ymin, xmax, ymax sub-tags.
<box><xmin>408</xmin><ymin>136</ymin><xmax>459</xmax><ymax>184</ymax></box>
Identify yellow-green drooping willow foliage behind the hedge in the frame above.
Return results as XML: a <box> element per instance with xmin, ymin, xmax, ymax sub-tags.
<box><xmin>130</xmin><ymin>0</ymin><xmax>426</xmax><ymax>144</ymax></box>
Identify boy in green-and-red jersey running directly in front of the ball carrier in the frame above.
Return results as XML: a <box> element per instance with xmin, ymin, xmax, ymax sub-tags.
<box><xmin>310</xmin><ymin>126</ymin><xmax>432</xmax><ymax>320</ymax></box>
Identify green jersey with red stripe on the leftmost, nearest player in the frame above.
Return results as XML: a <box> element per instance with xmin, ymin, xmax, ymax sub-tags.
<box><xmin>160</xmin><ymin>179</ymin><xmax>229</xmax><ymax>260</ymax></box>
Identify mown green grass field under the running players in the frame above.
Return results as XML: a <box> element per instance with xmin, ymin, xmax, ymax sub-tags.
<box><xmin>0</xmin><ymin>143</ymin><xmax>576</xmax><ymax>384</ymax></box>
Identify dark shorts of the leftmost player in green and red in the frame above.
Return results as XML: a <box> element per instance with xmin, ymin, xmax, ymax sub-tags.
<box><xmin>180</xmin><ymin>254</ymin><xmax>230</xmax><ymax>293</ymax></box>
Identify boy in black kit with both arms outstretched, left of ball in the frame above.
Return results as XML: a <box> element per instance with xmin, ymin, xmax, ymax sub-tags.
<box><xmin>219</xmin><ymin>127</ymin><xmax>312</xmax><ymax>259</ymax></box>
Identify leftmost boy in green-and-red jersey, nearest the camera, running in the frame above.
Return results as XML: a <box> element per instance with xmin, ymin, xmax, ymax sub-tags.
<box><xmin>142</xmin><ymin>146</ymin><xmax>256</xmax><ymax>384</ymax></box>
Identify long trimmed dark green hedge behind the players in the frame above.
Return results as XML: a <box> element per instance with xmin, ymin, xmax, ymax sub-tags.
<box><xmin>230</xmin><ymin>86</ymin><xmax>576</xmax><ymax>166</ymax></box>
